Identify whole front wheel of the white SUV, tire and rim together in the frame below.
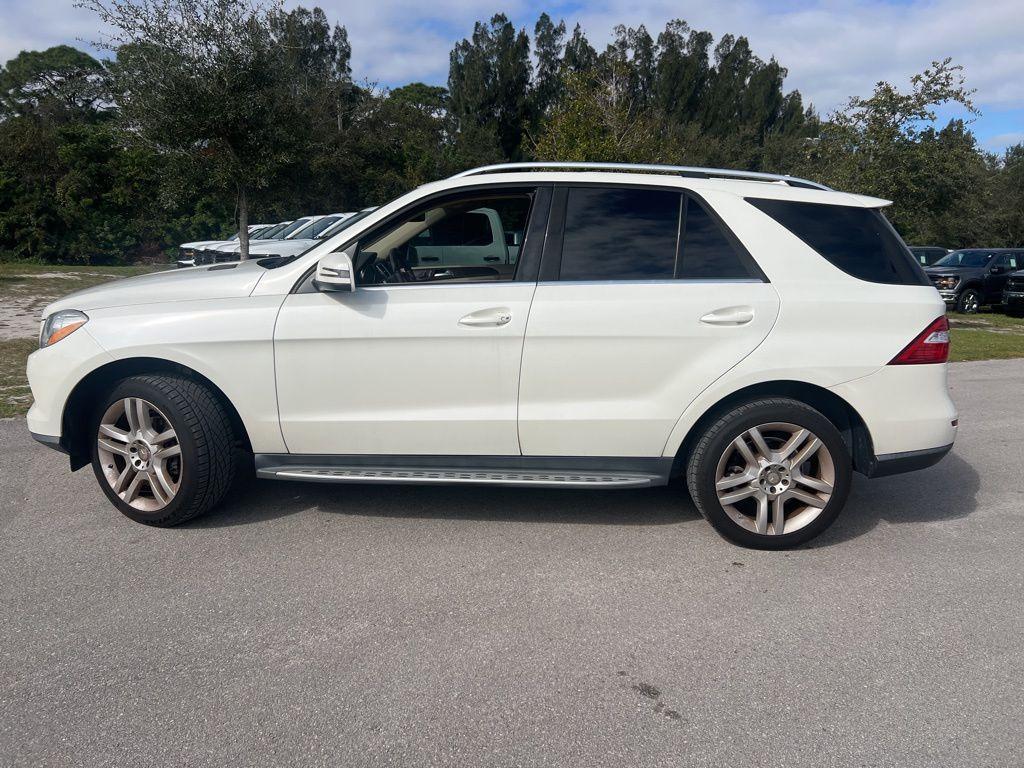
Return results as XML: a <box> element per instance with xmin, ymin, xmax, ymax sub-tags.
<box><xmin>92</xmin><ymin>376</ymin><xmax>237</xmax><ymax>526</ymax></box>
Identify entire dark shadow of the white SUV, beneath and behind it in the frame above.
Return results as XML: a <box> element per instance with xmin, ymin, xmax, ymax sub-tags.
<box><xmin>186</xmin><ymin>454</ymin><xmax>980</xmax><ymax>547</ymax></box>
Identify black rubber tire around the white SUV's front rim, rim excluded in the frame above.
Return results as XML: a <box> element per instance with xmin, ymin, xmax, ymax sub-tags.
<box><xmin>89</xmin><ymin>375</ymin><xmax>239</xmax><ymax>527</ymax></box>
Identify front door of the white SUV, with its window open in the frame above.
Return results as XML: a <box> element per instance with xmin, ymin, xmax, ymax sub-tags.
<box><xmin>274</xmin><ymin>186</ymin><xmax>550</xmax><ymax>456</ymax></box>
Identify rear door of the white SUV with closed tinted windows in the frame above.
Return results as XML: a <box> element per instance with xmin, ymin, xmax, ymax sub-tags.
<box><xmin>519</xmin><ymin>185</ymin><xmax>778</xmax><ymax>457</ymax></box>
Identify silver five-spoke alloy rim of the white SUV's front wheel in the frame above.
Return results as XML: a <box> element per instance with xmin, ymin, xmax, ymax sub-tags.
<box><xmin>96</xmin><ymin>397</ymin><xmax>182</xmax><ymax>512</ymax></box>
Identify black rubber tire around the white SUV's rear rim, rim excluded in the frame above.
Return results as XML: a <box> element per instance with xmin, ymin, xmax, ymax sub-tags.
<box><xmin>686</xmin><ymin>397</ymin><xmax>853</xmax><ymax>550</ymax></box>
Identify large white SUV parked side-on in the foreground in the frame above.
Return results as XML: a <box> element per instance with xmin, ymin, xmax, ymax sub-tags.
<box><xmin>29</xmin><ymin>164</ymin><xmax>957</xmax><ymax>548</ymax></box>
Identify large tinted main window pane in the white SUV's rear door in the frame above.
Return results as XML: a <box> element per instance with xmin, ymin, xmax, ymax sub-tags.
<box><xmin>559</xmin><ymin>187</ymin><xmax>680</xmax><ymax>280</ymax></box>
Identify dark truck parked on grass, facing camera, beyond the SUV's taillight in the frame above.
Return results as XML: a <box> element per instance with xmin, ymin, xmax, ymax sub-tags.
<box><xmin>925</xmin><ymin>248</ymin><xmax>1024</xmax><ymax>313</ymax></box>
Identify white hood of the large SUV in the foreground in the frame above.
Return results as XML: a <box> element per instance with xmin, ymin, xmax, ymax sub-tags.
<box><xmin>43</xmin><ymin>261</ymin><xmax>266</xmax><ymax>317</ymax></box>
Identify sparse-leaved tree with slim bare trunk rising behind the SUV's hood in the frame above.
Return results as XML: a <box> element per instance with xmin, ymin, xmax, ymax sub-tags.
<box><xmin>83</xmin><ymin>0</ymin><xmax>349</xmax><ymax>258</ymax></box>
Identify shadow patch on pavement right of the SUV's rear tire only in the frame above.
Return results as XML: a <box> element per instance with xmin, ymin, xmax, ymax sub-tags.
<box><xmin>807</xmin><ymin>453</ymin><xmax>981</xmax><ymax>548</ymax></box>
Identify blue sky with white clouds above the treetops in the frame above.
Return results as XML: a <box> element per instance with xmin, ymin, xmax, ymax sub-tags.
<box><xmin>0</xmin><ymin>0</ymin><xmax>1024</xmax><ymax>151</ymax></box>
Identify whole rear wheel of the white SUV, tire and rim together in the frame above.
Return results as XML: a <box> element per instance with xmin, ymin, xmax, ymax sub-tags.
<box><xmin>686</xmin><ymin>398</ymin><xmax>852</xmax><ymax>549</ymax></box>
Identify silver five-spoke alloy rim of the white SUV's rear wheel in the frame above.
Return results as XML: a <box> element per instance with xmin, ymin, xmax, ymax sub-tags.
<box><xmin>715</xmin><ymin>422</ymin><xmax>836</xmax><ymax>536</ymax></box>
